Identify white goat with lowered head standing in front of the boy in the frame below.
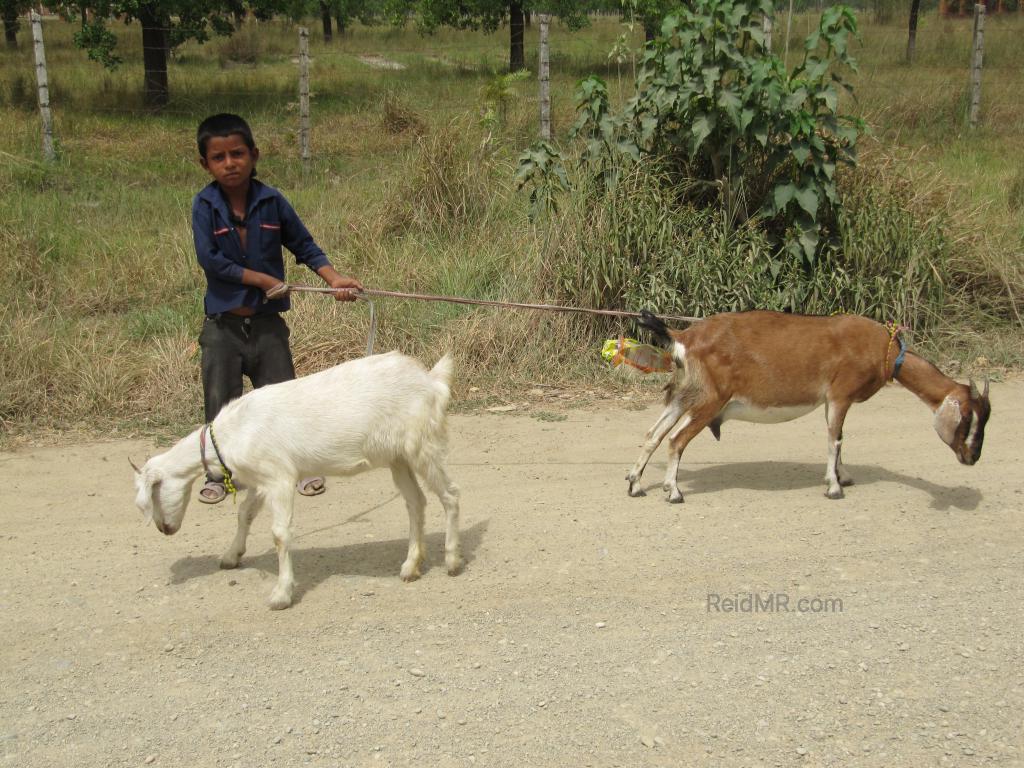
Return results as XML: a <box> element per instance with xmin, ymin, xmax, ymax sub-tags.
<box><xmin>133</xmin><ymin>352</ymin><xmax>463</xmax><ymax>609</ymax></box>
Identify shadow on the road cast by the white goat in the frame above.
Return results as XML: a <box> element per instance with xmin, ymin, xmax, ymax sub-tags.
<box><xmin>171</xmin><ymin>513</ymin><xmax>489</xmax><ymax>605</ymax></box>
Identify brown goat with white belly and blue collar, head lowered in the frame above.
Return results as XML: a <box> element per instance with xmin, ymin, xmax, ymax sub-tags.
<box><xmin>626</xmin><ymin>311</ymin><xmax>990</xmax><ymax>503</ymax></box>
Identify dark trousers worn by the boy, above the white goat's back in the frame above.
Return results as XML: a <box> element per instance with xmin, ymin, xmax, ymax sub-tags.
<box><xmin>199</xmin><ymin>313</ymin><xmax>295</xmax><ymax>422</ymax></box>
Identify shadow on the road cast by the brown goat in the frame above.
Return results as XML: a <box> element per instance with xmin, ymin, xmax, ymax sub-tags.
<box><xmin>644</xmin><ymin>462</ymin><xmax>982</xmax><ymax>512</ymax></box>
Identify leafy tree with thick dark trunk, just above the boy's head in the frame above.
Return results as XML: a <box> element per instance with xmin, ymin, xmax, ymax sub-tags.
<box><xmin>52</xmin><ymin>0</ymin><xmax>247</xmax><ymax>108</ymax></box>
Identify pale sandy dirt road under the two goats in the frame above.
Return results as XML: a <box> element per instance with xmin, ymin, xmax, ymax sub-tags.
<box><xmin>0</xmin><ymin>382</ymin><xmax>1024</xmax><ymax>768</ymax></box>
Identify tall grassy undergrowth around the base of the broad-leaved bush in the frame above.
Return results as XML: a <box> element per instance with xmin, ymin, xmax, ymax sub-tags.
<box><xmin>544</xmin><ymin>154</ymin><xmax>950</xmax><ymax>330</ymax></box>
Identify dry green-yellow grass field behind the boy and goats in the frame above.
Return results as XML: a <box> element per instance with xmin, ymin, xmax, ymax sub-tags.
<box><xmin>0</xmin><ymin>6</ymin><xmax>1024</xmax><ymax>439</ymax></box>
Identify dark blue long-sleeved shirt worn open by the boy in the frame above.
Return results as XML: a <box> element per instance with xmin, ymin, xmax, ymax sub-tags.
<box><xmin>193</xmin><ymin>179</ymin><xmax>331</xmax><ymax>314</ymax></box>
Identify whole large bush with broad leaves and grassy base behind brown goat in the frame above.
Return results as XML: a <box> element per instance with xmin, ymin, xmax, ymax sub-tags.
<box><xmin>517</xmin><ymin>0</ymin><xmax>951</xmax><ymax>328</ymax></box>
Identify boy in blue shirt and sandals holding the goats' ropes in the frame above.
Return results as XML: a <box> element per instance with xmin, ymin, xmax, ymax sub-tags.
<box><xmin>191</xmin><ymin>114</ymin><xmax>362</xmax><ymax>504</ymax></box>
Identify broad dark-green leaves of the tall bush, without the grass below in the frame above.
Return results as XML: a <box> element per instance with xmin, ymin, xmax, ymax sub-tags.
<box><xmin>520</xmin><ymin>0</ymin><xmax>863</xmax><ymax>264</ymax></box>
